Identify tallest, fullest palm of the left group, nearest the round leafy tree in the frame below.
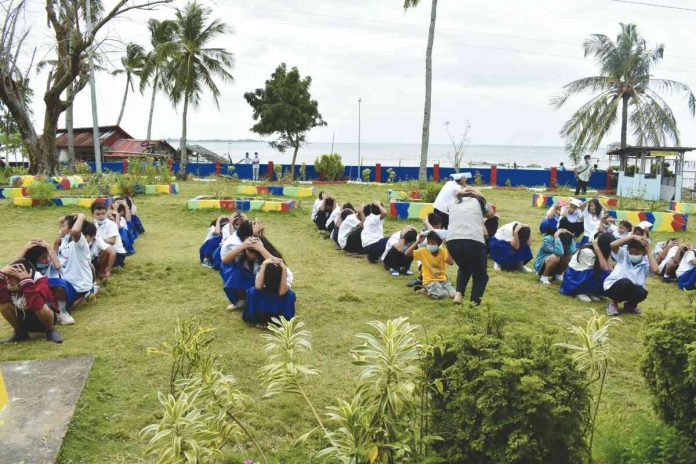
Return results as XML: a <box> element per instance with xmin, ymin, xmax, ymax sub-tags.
<box><xmin>162</xmin><ymin>1</ymin><xmax>232</xmax><ymax>179</ymax></box>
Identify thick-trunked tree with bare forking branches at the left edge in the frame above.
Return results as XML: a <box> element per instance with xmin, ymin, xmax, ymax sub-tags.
<box><xmin>0</xmin><ymin>0</ymin><xmax>171</xmax><ymax>175</ymax></box>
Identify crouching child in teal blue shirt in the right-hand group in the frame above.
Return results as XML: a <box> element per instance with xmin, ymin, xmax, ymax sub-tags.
<box><xmin>534</xmin><ymin>228</ymin><xmax>575</xmax><ymax>285</ymax></box>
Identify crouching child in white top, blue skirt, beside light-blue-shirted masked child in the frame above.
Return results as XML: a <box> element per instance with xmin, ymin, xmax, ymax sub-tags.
<box><xmin>560</xmin><ymin>233</ymin><xmax>614</xmax><ymax>303</ymax></box>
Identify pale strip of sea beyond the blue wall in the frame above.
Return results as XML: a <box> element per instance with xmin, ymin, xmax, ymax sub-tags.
<box><xmin>181</xmin><ymin>140</ymin><xmax>609</xmax><ymax>168</ymax></box>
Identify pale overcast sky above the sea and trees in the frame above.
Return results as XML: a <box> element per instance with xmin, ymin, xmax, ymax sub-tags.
<box><xmin>17</xmin><ymin>0</ymin><xmax>696</xmax><ymax>146</ymax></box>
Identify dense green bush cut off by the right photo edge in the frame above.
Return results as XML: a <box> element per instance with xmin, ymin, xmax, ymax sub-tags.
<box><xmin>641</xmin><ymin>311</ymin><xmax>696</xmax><ymax>437</ymax></box>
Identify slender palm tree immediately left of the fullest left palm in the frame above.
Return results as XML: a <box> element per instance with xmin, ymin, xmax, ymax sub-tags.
<box><xmin>140</xmin><ymin>19</ymin><xmax>175</xmax><ymax>140</ymax></box>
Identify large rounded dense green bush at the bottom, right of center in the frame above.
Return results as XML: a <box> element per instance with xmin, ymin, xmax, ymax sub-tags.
<box><xmin>428</xmin><ymin>316</ymin><xmax>590</xmax><ymax>464</ymax></box>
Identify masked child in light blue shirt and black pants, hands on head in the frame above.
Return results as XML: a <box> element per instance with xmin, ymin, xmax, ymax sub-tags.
<box><xmin>604</xmin><ymin>235</ymin><xmax>659</xmax><ymax>316</ymax></box>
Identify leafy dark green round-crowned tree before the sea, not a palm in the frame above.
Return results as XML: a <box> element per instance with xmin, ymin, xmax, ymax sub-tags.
<box><xmin>244</xmin><ymin>63</ymin><xmax>326</xmax><ymax>178</ymax></box>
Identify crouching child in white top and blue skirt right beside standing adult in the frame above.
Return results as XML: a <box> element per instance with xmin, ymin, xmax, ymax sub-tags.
<box><xmin>490</xmin><ymin>222</ymin><xmax>534</xmax><ymax>272</ymax></box>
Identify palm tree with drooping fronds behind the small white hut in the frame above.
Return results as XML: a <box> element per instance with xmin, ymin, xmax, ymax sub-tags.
<box><xmin>552</xmin><ymin>24</ymin><xmax>696</xmax><ymax>161</ymax></box>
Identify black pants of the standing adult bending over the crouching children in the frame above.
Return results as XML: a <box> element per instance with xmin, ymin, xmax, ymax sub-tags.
<box><xmin>447</xmin><ymin>240</ymin><xmax>488</xmax><ymax>303</ymax></box>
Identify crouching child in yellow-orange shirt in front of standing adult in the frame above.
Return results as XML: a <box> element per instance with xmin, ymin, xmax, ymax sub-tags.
<box><xmin>404</xmin><ymin>231</ymin><xmax>456</xmax><ymax>300</ymax></box>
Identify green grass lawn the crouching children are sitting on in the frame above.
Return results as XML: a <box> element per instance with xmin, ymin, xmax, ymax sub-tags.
<box><xmin>0</xmin><ymin>182</ymin><xmax>696</xmax><ymax>463</ymax></box>
